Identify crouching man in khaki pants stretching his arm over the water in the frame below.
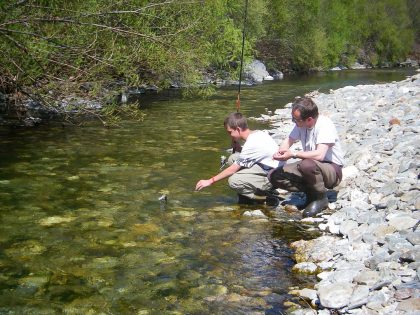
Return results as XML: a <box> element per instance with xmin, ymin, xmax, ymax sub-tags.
<box><xmin>195</xmin><ymin>113</ymin><xmax>283</xmax><ymax>205</ymax></box>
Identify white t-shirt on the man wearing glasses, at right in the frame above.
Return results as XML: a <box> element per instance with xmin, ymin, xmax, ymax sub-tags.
<box><xmin>289</xmin><ymin>115</ymin><xmax>344</xmax><ymax>165</ymax></box>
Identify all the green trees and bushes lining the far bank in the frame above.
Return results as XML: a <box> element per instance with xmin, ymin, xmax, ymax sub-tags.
<box><xmin>0</xmin><ymin>0</ymin><xmax>419</xmax><ymax>124</ymax></box>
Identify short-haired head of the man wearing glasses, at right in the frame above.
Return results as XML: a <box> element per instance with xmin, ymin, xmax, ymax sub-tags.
<box><xmin>292</xmin><ymin>97</ymin><xmax>319</xmax><ymax>128</ymax></box>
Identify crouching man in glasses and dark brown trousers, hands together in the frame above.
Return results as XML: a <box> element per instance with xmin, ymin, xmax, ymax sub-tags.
<box><xmin>268</xmin><ymin>97</ymin><xmax>344</xmax><ymax>217</ymax></box>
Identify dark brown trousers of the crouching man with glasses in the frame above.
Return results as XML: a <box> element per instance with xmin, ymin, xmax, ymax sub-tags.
<box><xmin>268</xmin><ymin>159</ymin><xmax>342</xmax><ymax>193</ymax></box>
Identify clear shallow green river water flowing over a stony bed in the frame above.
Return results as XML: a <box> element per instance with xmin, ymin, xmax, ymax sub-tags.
<box><xmin>0</xmin><ymin>71</ymin><xmax>414</xmax><ymax>314</ymax></box>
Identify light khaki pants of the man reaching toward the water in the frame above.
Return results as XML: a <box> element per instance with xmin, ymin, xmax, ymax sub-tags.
<box><xmin>227</xmin><ymin>153</ymin><xmax>273</xmax><ymax>199</ymax></box>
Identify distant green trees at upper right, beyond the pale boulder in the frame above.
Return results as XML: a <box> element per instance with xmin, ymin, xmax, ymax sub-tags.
<box><xmin>257</xmin><ymin>0</ymin><xmax>419</xmax><ymax>71</ymax></box>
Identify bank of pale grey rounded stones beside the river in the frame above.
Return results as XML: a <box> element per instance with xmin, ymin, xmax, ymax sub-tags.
<box><xmin>261</xmin><ymin>74</ymin><xmax>420</xmax><ymax>314</ymax></box>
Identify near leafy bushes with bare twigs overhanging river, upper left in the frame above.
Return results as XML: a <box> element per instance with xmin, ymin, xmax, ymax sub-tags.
<box><xmin>0</xmin><ymin>0</ymin><xmax>259</xmax><ymax>123</ymax></box>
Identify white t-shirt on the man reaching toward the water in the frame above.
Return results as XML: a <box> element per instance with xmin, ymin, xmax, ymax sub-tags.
<box><xmin>235</xmin><ymin>130</ymin><xmax>283</xmax><ymax>169</ymax></box>
